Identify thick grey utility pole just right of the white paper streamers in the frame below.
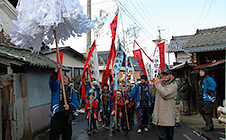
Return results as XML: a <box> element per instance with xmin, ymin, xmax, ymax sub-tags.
<box><xmin>86</xmin><ymin>0</ymin><xmax>91</xmax><ymax>54</ymax></box>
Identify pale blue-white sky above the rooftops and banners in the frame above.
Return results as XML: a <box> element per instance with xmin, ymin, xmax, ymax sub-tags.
<box><xmin>54</xmin><ymin>0</ymin><xmax>226</xmax><ymax>64</ymax></box>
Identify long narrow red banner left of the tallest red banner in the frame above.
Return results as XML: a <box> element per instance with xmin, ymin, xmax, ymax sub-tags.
<box><xmin>82</xmin><ymin>40</ymin><xmax>96</xmax><ymax>99</ymax></box>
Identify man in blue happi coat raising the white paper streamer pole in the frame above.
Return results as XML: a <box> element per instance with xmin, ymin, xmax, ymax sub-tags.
<box><xmin>49</xmin><ymin>64</ymin><xmax>78</xmax><ymax>140</ymax></box>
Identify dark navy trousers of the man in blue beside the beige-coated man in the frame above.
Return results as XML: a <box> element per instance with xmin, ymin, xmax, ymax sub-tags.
<box><xmin>138</xmin><ymin>103</ymin><xmax>149</xmax><ymax>129</ymax></box>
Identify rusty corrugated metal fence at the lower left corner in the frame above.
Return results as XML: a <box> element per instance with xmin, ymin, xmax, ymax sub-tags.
<box><xmin>0</xmin><ymin>74</ymin><xmax>32</xmax><ymax>140</ymax></box>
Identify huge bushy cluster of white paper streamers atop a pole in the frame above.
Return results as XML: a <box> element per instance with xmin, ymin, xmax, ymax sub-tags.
<box><xmin>11</xmin><ymin>0</ymin><xmax>95</xmax><ymax>52</ymax></box>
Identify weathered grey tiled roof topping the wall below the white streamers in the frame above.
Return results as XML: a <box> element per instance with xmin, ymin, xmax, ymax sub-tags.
<box><xmin>0</xmin><ymin>45</ymin><xmax>56</xmax><ymax>68</ymax></box>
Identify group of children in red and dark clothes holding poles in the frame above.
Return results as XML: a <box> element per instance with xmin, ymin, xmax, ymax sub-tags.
<box><xmin>85</xmin><ymin>82</ymin><xmax>135</xmax><ymax>136</ymax></box>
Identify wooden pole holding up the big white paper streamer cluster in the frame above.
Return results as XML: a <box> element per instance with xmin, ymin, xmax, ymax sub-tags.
<box><xmin>53</xmin><ymin>30</ymin><xmax>67</xmax><ymax>105</ymax></box>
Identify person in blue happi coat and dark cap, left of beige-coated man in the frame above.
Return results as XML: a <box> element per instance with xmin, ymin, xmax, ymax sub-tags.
<box><xmin>125</xmin><ymin>75</ymin><xmax>151</xmax><ymax>134</ymax></box>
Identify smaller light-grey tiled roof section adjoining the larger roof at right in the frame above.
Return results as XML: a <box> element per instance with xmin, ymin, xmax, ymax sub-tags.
<box><xmin>166</xmin><ymin>35</ymin><xmax>194</xmax><ymax>52</ymax></box>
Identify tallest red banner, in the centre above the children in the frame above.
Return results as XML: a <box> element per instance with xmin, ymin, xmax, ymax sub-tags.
<box><xmin>101</xmin><ymin>11</ymin><xmax>118</xmax><ymax>89</ymax></box>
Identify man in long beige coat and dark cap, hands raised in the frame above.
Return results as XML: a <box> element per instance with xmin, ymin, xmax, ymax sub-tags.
<box><xmin>150</xmin><ymin>69</ymin><xmax>177</xmax><ymax>140</ymax></box>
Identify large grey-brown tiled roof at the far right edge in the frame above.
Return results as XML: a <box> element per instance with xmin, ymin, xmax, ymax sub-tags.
<box><xmin>183</xmin><ymin>26</ymin><xmax>226</xmax><ymax>52</ymax></box>
